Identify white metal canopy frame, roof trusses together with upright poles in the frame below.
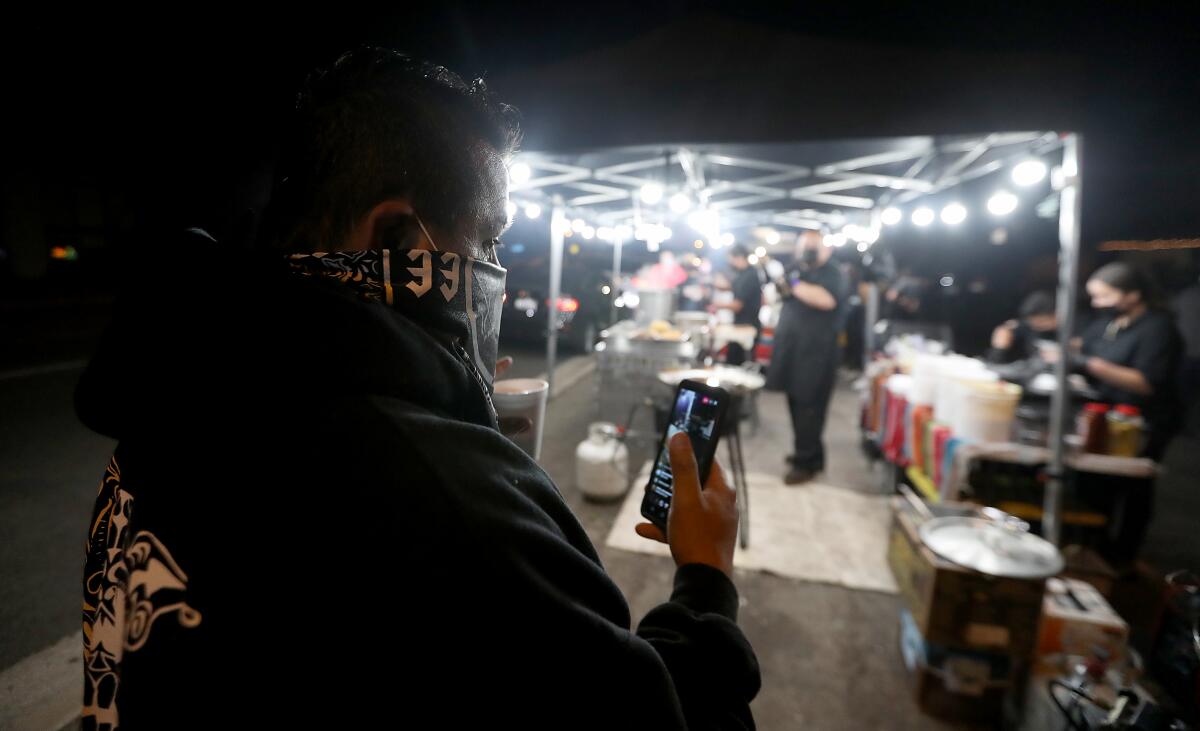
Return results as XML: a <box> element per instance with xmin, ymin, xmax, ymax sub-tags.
<box><xmin>511</xmin><ymin>132</ymin><xmax>1081</xmax><ymax>544</ymax></box>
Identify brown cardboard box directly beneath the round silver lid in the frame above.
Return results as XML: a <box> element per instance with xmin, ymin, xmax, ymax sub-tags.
<box><xmin>888</xmin><ymin>501</ymin><xmax>1045</xmax><ymax>659</ymax></box>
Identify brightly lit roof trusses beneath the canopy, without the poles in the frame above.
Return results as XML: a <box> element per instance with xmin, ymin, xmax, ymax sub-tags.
<box><xmin>511</xmin><ymin>132</ymin><xmax>1062</xmax><ymax>241</ymax></box>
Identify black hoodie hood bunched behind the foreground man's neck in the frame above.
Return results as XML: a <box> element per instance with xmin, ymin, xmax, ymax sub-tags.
<box><xmin>76</xmin><ymin>229</ymin><xmax>496</xmax><ymax>439</ymax></box>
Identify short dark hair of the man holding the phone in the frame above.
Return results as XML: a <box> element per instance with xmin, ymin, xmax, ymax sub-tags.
<box><xmin>264</xmin><ymin>47</ymin><xmax>520</xmax><ymax>251</ymax></box>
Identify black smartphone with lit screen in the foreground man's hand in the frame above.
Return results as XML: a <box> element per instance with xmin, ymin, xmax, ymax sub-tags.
<box><xmin>642</xmin><ymin>381</ymin><xmax>730</xmax><ymax>535</ymax></box>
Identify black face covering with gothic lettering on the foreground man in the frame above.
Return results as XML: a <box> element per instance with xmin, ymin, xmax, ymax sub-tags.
<box><xmin>288</xmin><ymin>248</ymin><xmax>508</xmax><ymax>388</ymax></box>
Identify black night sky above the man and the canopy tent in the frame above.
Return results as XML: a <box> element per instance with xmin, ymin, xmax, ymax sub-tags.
<box><xmin>2</xmin><ymin>1</ymin><xmax>1200</xmax><ymax>265</ymax></box>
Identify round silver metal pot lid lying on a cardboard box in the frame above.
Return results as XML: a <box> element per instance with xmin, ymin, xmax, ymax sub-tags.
<box><xmin>920</xmin><ymin>516</ymin><xmax>1063</xmax><ymax>579</ymax></box>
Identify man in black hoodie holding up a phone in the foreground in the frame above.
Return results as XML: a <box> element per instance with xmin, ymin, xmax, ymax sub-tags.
<box><xmin>76</xmin><ymin>49</ymin><xmax>760</xmax><ymax>730</ymax></box>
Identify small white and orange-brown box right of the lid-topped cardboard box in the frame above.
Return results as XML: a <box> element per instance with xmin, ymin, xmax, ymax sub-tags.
<box><xmin>1038</xmin><ymin>579</ymin><xmax>1129</xmax><ymax>664</ymax></box>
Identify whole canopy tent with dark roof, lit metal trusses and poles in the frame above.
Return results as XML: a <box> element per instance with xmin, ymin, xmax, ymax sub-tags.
<box><xmin>491</xmin><ymin>16</ymin><xmax>1090</xmax><ymax>541</ymax></box>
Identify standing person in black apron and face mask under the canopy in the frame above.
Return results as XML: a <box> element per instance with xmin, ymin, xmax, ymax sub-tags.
<box><xmin>767</xmin><ymin>230</ymin><xmax>845</xmax><ymax>485</ymax></box>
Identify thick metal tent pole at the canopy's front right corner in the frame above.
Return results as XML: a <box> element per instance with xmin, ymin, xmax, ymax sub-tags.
<box><xmin>1042</xmin><ymin>133</ymin><xmax>1082</xmax><ymax>545</ymax></box>
